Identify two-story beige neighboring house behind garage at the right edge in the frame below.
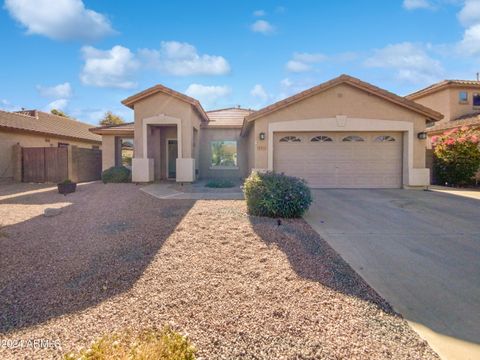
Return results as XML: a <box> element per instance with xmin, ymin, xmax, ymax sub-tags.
<box><xmin>406</xmin><ymin>80</ymin><xmax>480</xmax><ymax>145</ymax></box>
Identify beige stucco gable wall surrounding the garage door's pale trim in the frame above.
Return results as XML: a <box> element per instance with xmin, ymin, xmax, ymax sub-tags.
<box><xmin>250</xmin><ymin>84</ymin><xmax>426</xmax><ymax>169</ymax></box>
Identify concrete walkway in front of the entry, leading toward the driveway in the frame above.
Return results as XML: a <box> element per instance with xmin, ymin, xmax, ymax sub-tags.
<box><xmin>140</xmin><ymin>182</ymin><xmax>244</xmax><ymax>200</ymax></box>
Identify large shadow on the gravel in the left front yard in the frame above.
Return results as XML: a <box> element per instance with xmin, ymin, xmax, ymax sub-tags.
<box><xmin>0</xmin><ymin>183</ymin><xmax>194</xmax><ymax>333</ymax></box>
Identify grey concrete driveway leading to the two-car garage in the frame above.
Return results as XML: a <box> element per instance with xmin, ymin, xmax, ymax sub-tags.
<box><xmin>305</xmin><ymin>189</ymin><xmax>480</xmax><ymax>359</ymax></box>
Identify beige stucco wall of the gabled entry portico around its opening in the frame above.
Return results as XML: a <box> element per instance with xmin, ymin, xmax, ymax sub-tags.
<box><xmin>134</xmin><ymin>93</ymin><xmax>200</xmax><ymax>158</ymax></box>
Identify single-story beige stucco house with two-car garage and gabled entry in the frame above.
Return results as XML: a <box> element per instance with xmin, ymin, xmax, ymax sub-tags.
<box><xmin>91</xmin><ymin>75</ymin><xmax>443</xmax><ymax>188</ymax></box>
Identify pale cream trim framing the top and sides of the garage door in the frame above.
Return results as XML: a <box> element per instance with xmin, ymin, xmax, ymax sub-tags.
<box><xmin>267</xmin><ymin>115</ymin><xmax>427</xmax><ymax>186</ymax></box>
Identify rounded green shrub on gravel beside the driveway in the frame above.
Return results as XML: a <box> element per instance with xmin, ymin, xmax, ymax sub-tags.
<box><xmin>243</xmin><ymin>172</ymin><xmax>312</xmax><ymax>218</ymax></box>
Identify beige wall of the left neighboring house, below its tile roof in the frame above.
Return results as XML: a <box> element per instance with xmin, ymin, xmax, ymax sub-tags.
<box><xmin>0</xmin><ymin>130</ymin><xmax>99</xmax><ymax>179</ymax></box>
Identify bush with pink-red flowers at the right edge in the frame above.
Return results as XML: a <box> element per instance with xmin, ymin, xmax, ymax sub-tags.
<box><xmin>432</xmin><ymin>126</ymin><xmax>480</xmax><ymax>186</ymax></box>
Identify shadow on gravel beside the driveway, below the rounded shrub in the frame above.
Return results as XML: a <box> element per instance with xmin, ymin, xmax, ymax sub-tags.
<box><xmin>250</xmin><ymin>216</ymin><xmax>396</xmax><ymax>314</ymax></box>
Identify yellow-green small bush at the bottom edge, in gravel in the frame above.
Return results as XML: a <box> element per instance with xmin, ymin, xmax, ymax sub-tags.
<box><xmin>64</xmin><ymin>327</ymin><xmax>196</xmax><ymax>360</ymax></box>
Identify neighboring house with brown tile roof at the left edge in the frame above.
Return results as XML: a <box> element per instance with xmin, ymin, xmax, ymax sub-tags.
<box><xmin>0</xmin><ymin>110</ymin><xmax>102</xmax><ymax>180</ymax></box>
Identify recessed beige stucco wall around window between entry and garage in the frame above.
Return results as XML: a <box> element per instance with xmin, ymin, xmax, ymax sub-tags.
<box><xmin>199</xmin><ymin>128</ymin><xmax>248</xmax><ymax>178</ymax></box>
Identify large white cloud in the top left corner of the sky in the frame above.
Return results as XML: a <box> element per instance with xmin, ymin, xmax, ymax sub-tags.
<box><xmin>5</xmin><ymin>0</ymin><xmax>115</xmax><ymax>40</ymax></box>
